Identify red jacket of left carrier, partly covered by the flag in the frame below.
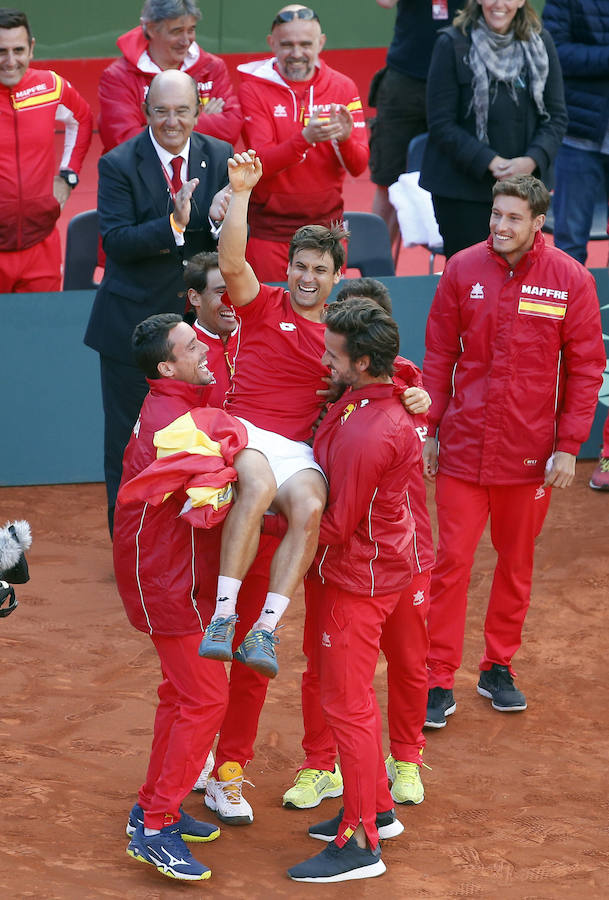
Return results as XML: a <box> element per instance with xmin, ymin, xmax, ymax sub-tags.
<box><xmin>112</xmin><ymin>378</ymin><xmax>214</xmax><ymax>635</ymax></box>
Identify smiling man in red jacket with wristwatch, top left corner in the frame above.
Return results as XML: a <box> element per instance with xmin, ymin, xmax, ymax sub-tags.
<box><xmin>0</xmin><ymin>9</ymin><xmax>93</xmax><ymax>294</ymax></box>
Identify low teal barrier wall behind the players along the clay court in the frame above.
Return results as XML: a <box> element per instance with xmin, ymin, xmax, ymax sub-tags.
<box><xmin>0</xmin><ymin>269</ymin><xmax>609</xmax><ymax>486</ymax></box>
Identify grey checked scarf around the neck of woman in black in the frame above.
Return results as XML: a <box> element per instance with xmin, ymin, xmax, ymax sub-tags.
<box><xmin>469</xmin><ymin>16</ymin><xmax>550</xmax><ymax>144</ymax></box>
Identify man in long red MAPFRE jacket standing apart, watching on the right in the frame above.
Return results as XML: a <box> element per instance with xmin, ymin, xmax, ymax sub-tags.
<box><xmin>423</xmin><ymin>175</ymin><xmax>605</xmax><ymax>728</ymax></box>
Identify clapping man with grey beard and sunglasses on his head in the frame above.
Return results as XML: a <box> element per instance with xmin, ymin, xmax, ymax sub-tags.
<box><xmin>239</xmin><ymin>4</ymin><xmax>369</xmax><ymax>282</ymax></box>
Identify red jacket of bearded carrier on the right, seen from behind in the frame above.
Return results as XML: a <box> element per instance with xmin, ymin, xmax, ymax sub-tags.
<box><xmin>313</xmin><ymin>383</ymin><xmax>422</xmax><ymax>596</ymax></box>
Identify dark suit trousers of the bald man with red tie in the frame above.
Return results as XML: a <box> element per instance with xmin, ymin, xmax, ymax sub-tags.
<box><xmin>99</xmin><ymin>355</ymin><xmax>148</xmax><ymax>536</ymax></box>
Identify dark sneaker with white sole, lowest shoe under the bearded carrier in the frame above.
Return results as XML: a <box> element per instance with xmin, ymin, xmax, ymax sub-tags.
<box><xmin>288</xmin><ymin>837</ymin><xmax>386</xmax><ymax>884</ymax></box>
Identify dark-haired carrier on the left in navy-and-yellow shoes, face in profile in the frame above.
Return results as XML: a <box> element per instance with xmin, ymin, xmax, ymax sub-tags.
<box><xmin>113</xmin><ymin>313</ymin><xmax>235</xmax><ymax>881</ymax></box>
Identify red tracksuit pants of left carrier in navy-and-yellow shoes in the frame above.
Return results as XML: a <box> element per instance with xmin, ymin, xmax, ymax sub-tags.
<box><xmin>139</xmin><ymin>632</ymin><xmax>228</xmax><ymax>828</ymax></box>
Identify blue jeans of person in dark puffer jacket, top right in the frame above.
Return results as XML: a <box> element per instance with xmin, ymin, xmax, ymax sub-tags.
<box><xmin>552</xmin><ymin>144</ymin><xmax>609</xmax><ymax>265</ymax></box>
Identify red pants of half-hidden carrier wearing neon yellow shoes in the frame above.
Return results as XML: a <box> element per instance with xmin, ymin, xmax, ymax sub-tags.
<box><xmin>300</xmin><ymin>571</ymin><xmax>431</xmax><ymax>768</ymax></box>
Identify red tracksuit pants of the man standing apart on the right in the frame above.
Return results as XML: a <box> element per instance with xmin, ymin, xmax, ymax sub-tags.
<box><xmin>427</xmin><ymin>473</ymin><xmax>550</xmax><ymax>688</ymax></box>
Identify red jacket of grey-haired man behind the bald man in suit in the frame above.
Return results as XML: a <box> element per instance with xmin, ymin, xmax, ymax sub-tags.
<box><xmin>98</xmin><ymin>25</ymin><xmax>242</xmax><ymax>153</ymax></box>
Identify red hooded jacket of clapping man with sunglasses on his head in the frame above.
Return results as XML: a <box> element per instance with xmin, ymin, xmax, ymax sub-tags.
<box><xmin>238</xmin><ymin>59</ymin><xmax>369</xmax><ymax>241</ymax></box>
